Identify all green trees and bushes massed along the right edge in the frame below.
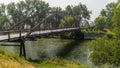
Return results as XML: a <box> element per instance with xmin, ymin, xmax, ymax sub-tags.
<box><xmin>88</xmin><ymin>1</ymin><xmax>120</xmax><ymax>67</ymax></box>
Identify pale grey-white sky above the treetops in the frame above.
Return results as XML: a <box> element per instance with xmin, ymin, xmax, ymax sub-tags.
<box><xmin>0</xmin><ymin>0</ymin><xmax>117</xmax><ymax>21</ymax></box>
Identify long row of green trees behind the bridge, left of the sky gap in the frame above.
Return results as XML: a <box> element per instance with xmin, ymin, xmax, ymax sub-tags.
<box><xmin>0</xmin><ymin>0</ymin><xmax>90</xmax><ymax>30</ymax></box>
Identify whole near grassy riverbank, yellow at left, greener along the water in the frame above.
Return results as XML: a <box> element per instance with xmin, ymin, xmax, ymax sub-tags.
<box><xmin>0</xmin><ymin>50</ymin><xmax>89</xmax><ymax>68</ymax></box>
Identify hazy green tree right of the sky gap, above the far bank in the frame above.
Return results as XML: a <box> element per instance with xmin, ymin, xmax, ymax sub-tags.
<box><xmin>94</xmin><ymin>2</ymin><xmax>116</xmax><ymax>31</ymax></box>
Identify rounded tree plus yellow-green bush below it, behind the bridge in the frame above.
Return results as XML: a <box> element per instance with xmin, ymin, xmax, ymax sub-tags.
<box><xmin>59</xmin><ymin>3</ymin><xmax>90</xmax><ymax>27</ymax></box>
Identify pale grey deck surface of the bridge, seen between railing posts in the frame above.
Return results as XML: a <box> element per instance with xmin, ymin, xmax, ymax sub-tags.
<box><xmin>0</xmin><ymin>28</ymin><xmax>79</xmax><ymax>41</ymax></box>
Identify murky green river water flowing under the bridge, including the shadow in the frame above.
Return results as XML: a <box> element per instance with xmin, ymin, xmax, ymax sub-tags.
<box><xmin>2</xmin><ymin>38</ymin><xmax>92</xmax><ymax>65</ymax></box>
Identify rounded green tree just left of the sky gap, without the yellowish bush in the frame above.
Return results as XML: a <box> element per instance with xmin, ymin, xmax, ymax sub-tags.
<box><xmin>65</xmin><ymin>3</ymin><xmax>91</xmax><ymax>27</ymax></box>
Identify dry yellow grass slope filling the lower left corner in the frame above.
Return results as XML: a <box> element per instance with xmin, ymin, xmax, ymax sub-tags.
<box><xmin>0</xmin><ymin>50</ymin><xmax>36</xmax><ymax>68</ymax></box>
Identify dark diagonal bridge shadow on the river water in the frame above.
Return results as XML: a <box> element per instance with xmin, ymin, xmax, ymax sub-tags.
<box><xmin>56</xmin><ymin>40</ymin><xmax>84</xmax><ymax>58</ymax></box>
